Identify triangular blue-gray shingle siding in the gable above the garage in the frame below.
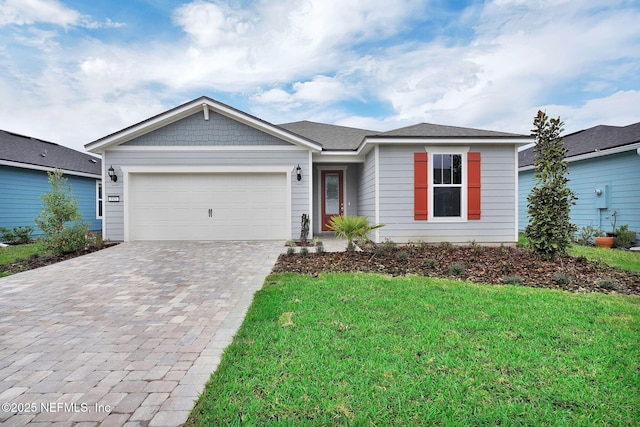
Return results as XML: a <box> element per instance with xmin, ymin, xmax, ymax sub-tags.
<box><xmin>122</xmin><ymin>111</ymin><xmax>289</xmax><ymax>146</ymax></box>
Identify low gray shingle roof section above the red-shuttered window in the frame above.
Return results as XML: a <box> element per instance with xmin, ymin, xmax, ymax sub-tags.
<box><xmin>375</xmin><ymin>123</ymin><xmax>529</xmax><ymax>139</ymax></box>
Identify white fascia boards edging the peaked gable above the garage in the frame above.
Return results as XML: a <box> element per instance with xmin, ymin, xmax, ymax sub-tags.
<box><xmin>85</xmin><ymin>98</ymin><xmax>322</xmax><ymax>153</ymax></box>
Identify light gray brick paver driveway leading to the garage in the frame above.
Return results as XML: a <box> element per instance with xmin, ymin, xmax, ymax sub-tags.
<box><xmin>0</xmin><ymin>242</ymin><xmax>283</xmax><ymax>426</ymax></box>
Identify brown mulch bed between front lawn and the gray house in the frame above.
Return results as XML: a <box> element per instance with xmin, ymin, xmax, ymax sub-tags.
<box><xmin>273</xmin><ymin>244</ymin><xmax>640</xmax><ymax>295</ymax></box>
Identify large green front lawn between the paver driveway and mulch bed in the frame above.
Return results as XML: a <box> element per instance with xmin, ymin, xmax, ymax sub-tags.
<box><xmin>187</xmin><ymin>274</ymin><xmax>640</xmax><ymax>426</ymax></box>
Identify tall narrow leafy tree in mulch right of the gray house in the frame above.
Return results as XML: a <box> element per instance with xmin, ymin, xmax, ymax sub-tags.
<box><xmin>525</xmin><ymin>111</ymin><xmax>577</xmax><ymax>259</ymax></box>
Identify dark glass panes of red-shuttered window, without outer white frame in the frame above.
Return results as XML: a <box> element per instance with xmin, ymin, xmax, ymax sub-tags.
<box><xmin>432</xmin><ymin>154</ymin><xmax>462</xmax><ymax>218</ymax></box>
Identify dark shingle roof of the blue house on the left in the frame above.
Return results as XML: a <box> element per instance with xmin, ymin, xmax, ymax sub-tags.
<box><xmin>0</xmin><ymin>130</ymin><xmax>102</xmax><ymax>178</ymax></box>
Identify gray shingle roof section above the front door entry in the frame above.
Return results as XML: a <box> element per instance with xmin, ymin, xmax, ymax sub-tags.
<box><xmin>278</xmin><ymin>120</ymin><xmax>377</xmax><ymax>150</ymax></box>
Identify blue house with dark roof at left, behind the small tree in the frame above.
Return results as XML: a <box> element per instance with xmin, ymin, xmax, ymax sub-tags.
<box><xmin>0</xmin><ymin>130</ymin><xmax>102</xmax><ymax>236</ymax></box>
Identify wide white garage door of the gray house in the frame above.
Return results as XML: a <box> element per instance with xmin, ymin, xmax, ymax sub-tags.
<box><xmin>129</xmin><ymin>173</ymin><xmax>290</xmax><ymax>240</ymax></box>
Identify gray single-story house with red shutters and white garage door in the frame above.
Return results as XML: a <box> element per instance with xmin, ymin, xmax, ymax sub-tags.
<box><xmin>86</xmin><ymin>97</ymin><xmax>533</xmax><ymax>244</ymax></box>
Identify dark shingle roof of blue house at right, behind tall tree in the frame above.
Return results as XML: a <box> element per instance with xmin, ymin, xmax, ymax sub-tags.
<box><xmin>518</xmin><ymin>122</ymin><xmax>640</xmax><ymax>167</ymax></box>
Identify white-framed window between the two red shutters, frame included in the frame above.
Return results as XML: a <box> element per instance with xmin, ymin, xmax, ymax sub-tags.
<box><xmin>428</xmin><ymin>148</ymin><xmax>468</xmax><ymax>222</ymax></box>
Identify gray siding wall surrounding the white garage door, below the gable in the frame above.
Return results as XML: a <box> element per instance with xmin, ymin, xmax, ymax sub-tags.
<box><xmin>103</xmin><ymin>149</ymin><xmax>311</xmax><ymax>241</ymax></box>
